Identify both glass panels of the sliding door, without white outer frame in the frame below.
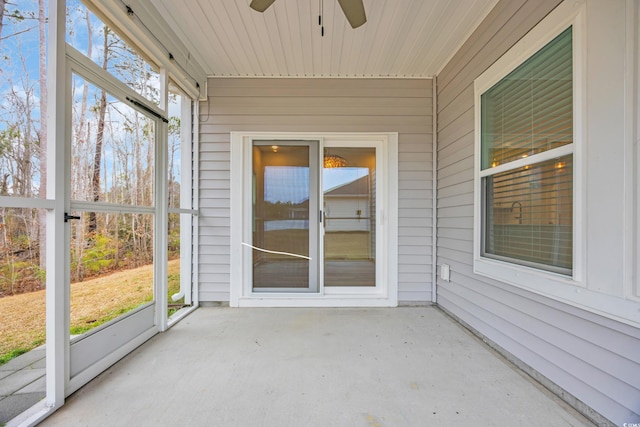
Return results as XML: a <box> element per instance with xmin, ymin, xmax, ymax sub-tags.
<box><xmin>250</xmin><ymin>140</ymin><xmax>378</xmax><ymax>293</ymax></box>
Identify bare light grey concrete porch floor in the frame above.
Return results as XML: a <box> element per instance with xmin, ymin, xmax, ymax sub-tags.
<box><xmin>42</xmin><ymin>307</ymin><xmax>592</xmax><ymax>427</ymax></box>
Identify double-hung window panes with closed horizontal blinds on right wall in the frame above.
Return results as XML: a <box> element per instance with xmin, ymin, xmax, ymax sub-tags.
<box><xmin>480</xmin><ymin>27</ymin><xmax>573</xmax><ymax>275</ymax></box>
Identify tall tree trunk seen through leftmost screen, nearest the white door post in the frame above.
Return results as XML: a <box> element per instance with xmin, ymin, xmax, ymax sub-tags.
<box><xmin>37</xmin><ymin>0</ymin><xmax>48</xmax><ymax>270</ymax></box>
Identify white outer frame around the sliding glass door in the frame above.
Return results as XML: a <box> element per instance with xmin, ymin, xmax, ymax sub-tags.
<box><xmin>229</xmin><ymin>132</ymin><xmax>398</xmax><ymax>307</ymax></box>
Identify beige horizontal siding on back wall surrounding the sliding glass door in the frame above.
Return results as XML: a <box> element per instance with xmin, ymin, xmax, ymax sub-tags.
<box><xmin>199</xmin><ymin>78</ymin><xmax>433</xmax><ymax>301</ymax></box>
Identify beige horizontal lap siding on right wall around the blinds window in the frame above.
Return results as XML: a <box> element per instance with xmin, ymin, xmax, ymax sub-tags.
<box><xmin>437</xmin><ymin>0</ymin><xmax>640</xmax><ymax>425</ymax></box>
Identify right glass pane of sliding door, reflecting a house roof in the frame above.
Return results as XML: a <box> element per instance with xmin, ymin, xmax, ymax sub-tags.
<box><xmin>322</xmin><ymin>147</ymin><xmax>376</xmax><ymax>287</ymax></box>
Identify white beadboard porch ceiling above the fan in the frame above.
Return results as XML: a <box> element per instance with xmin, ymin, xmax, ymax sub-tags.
<box><xmin>151</xmin><ymin>0</ymin><xmax>497</xmax><ymax>77</ymax></box>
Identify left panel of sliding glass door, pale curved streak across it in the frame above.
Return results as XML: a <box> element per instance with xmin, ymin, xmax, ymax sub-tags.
<box><xmin>252</xmin><ymin>141</ymin><xmax>318</xmax><ymax>292</ymax></box>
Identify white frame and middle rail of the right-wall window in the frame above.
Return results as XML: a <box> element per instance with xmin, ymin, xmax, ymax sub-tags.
<box><xmin>473</xmin><ymin>2</ymin><xmax>586</xmax><ymax>301</ymax></box>
